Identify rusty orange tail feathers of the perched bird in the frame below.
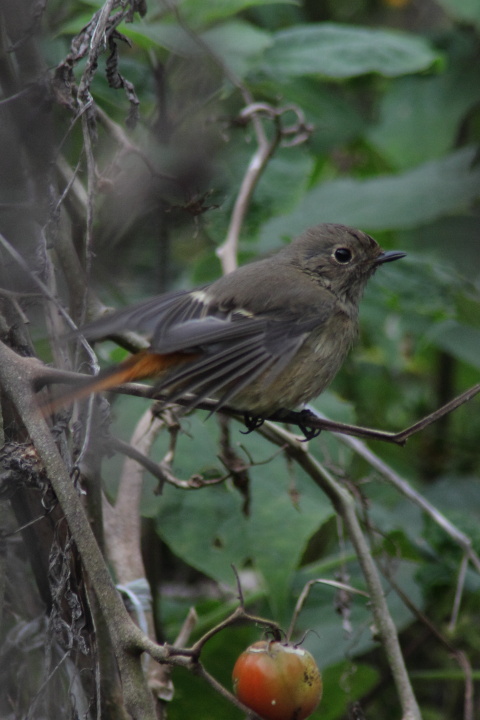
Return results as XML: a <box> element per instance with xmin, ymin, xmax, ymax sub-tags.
<box><xmin>40</xmin><ymin>350</ymin><xmax>197</xmax><ymax>417</ymax></box>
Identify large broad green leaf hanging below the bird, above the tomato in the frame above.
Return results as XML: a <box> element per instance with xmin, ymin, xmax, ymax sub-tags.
<box><xmin>150</xmin><ymin>420</ymin><xmax>333</xmax><ymax>617</ymax></box>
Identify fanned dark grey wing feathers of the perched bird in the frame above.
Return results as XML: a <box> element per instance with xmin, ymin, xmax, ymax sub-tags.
<box><xmin>84</xmin><ymin>288</ymin><xmax>318</xmax><ymax>406</ymax></box>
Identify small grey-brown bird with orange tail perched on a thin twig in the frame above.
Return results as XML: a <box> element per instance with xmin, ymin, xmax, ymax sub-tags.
<box><xmin>44</xmin><ymin>224</ymin><xmax>405</xmax><ymax>417</ymax></box>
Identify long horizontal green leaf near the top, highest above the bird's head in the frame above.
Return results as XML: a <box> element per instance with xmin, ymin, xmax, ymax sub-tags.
<box><xmin>265</xmin><ymin>23</ymin><xmax>440</xmax><ymax>79</ymax></box>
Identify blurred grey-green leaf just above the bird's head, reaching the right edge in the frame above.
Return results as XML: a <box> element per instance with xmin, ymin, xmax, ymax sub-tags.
<box><xmin>260</xmin><ymin>148</ymin><xmax>480</xmax><ymax>245</ymax></box>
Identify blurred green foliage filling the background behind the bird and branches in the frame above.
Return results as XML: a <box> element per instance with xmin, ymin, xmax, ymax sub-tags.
<box><xmin>2</xmin><ymin>0</ymin><xmax>480</xmax><ymax>720</ymax></box>
